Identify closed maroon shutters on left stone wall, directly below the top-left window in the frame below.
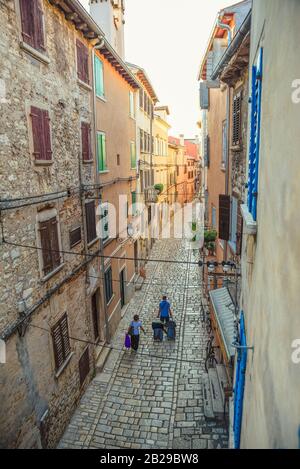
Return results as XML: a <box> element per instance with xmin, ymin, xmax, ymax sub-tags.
<box><xmin>30</xmin><ymin>106</ymin><xmax>52</xmax><ymax>163</ymax></box>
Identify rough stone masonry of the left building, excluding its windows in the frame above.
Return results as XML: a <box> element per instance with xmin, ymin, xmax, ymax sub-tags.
<box><xmin>0</xmin><ymin>0</ymin><xmax>100</xmax><ymax>448</ymax></box>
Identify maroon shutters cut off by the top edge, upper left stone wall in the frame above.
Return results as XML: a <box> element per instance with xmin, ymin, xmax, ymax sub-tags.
<box><xmin>19</xmin><ymin>0</ymin><xmax>45</xmax><ymax>51</ymax></box>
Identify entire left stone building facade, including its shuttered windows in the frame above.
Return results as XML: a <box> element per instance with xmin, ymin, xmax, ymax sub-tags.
<box><xmin>0</xmin><ymin>0</ymin><xmax>106</xmax><ymax>448</ymax></box>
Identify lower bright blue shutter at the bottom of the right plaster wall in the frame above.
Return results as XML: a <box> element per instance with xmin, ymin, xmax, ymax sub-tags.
<box><xmin>233</xmin><ymin>312</ymin><xmax>247</xmax><ymax>449</ymax></box>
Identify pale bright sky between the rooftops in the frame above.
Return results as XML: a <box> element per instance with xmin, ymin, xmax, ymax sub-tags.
<box><xmin>80</xmin><ymin>0</ymin><xmax>237</xmax><ymax>138</ymax></box>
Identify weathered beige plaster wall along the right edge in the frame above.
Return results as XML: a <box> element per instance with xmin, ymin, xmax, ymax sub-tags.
<box><xmin>241</xmin><ymin>0</ymin><xmax>300</xmax><ymax>448</ymax></box>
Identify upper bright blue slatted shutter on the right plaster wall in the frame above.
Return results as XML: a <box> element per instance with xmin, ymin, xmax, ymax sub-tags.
<box><xmin>248</xmin><ymin>49</ymin><xmax>263</xmax><ymax>221</ymax></box>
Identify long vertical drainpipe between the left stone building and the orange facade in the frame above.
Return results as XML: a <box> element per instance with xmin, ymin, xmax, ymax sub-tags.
<box><xmin>92</xmin><ymin>38</ymin><xmax>110</xmax><ymax>344</ymax></box>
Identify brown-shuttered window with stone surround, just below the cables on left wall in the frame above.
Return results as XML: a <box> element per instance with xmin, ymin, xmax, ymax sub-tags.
<box><xmin>39</xmin><ymin>216</ymin><xmax>61</xmax><ymax>276</ymax></box>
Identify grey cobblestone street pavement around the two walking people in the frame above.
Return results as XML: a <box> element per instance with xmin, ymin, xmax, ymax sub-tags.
<box><xmin>59</xmin><ymin>240</ymin><xmax>228</xmax><ymax>449</ymax></box>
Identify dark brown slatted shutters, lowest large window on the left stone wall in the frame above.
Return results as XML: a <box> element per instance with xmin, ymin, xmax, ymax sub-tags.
<box><xmin>51</xmin><ymin>313</ymin><xmax>71</xmax><ymax>371</ymax></box>
